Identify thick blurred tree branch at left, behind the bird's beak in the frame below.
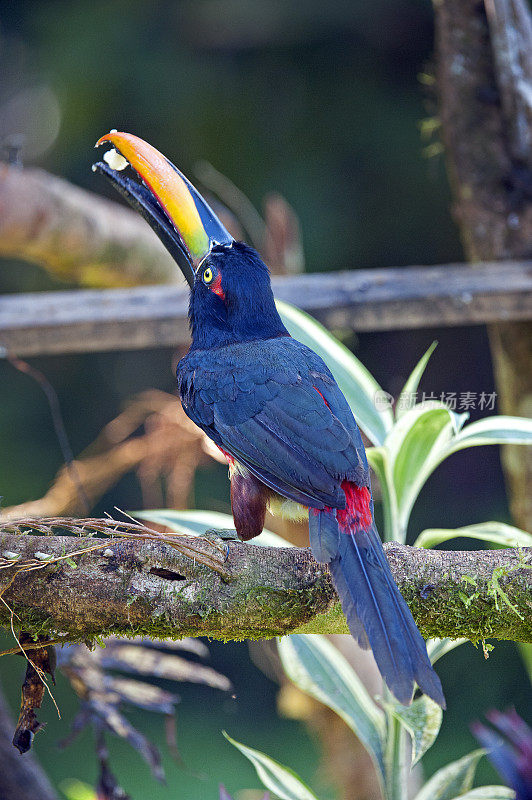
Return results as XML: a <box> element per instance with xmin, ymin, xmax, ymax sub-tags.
<box><xmin>0</xmin><ymin>164</ymin><xmax>181</xmax><ymax>287</ymax></box>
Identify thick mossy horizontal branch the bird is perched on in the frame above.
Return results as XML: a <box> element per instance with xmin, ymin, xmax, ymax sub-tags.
<box><xmin>0</xmin><ymin>520</ymin><xmax>532</xmax><ymax>642</ymax></box>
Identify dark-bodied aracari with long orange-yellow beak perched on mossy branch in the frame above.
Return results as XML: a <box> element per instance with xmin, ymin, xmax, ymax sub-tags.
<box><xmin>94</xmin><ymin>132</ymin><xmax>445</xmax><ymax>706</ymax></box>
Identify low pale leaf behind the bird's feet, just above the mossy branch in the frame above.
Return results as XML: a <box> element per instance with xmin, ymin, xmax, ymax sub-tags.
<box><xmin>132</xmin><ymin>508</ymin><xmax>292</xmax><ymax>547</ymax></box>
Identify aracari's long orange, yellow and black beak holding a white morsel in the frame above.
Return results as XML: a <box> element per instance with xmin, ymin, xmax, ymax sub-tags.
<box><xmin>93</xmin><ymin>131</ymin><xmax>233</xmax><ymax>287</ymax></box>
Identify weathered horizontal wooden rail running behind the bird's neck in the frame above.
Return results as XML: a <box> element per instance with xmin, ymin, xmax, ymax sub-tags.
<box><xmin>0</xmin><ymin>261</ymin><xmax>532</xmax><ymax>356</ymax></box>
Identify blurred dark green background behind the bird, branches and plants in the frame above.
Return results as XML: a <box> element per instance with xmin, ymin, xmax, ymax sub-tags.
<box><xmin>0</xmin><ymin>0</ymin><xmax>531</xmax><ymax>800</ymax></box>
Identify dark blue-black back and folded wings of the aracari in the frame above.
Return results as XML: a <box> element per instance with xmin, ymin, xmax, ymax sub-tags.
<box><xmin>178</xmin><ymin>337</ymin><xmax>368</xmax><ymax>508</ymax></box>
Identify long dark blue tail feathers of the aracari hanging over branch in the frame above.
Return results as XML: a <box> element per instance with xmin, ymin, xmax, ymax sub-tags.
<box><xmin>309</xmin><ymin>510</ymin><xmax>445</xmax><ymax>708</ymax></box>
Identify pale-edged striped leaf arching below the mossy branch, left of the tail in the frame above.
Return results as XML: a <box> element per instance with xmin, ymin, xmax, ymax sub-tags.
<box><xmin>279</xmin><ymin>634</ymin><xmax>386</xmax><ymax>779</ymax></box>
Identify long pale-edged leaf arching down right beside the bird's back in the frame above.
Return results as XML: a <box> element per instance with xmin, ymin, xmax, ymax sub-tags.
<box><xmin>277</xmin><ymin>300</ymin><xmax>393</xmax><ymax>444</ymax></box>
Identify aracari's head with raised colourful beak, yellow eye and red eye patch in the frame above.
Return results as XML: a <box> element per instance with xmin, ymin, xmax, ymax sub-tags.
<box><xmin>93</xmin><ymin>131</ymin><xmax>287</xmax><ymax>348</ymax></box>
